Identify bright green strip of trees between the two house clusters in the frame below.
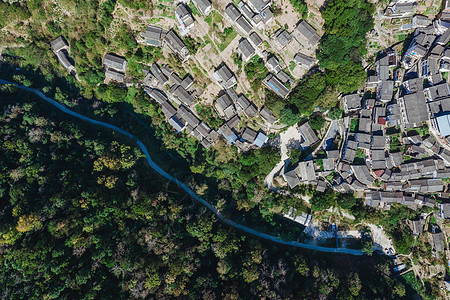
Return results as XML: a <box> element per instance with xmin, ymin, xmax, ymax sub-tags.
<box><xmin>281</xmin><ymin>0</ymin><xmax>375</xmax><ymax>124</ymax></box>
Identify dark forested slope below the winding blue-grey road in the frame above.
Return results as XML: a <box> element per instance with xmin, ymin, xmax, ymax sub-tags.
<box><xmin>0</xmin><ymin>85</ymin><xmax>404</xmax><ymax>299</ymax></box>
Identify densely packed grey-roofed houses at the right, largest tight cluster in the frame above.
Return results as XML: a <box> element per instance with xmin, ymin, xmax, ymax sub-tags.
<box><xmin>283</xmin><ymin>16</ymin><xmax>450</xmax><ymax>212</ymax></box>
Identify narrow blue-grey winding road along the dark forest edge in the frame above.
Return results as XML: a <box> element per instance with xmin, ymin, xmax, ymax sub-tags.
<box><xmin>0</xmin><ymin>79</ymin><xmax>364</xmax><ymax>255</ymax></box>
